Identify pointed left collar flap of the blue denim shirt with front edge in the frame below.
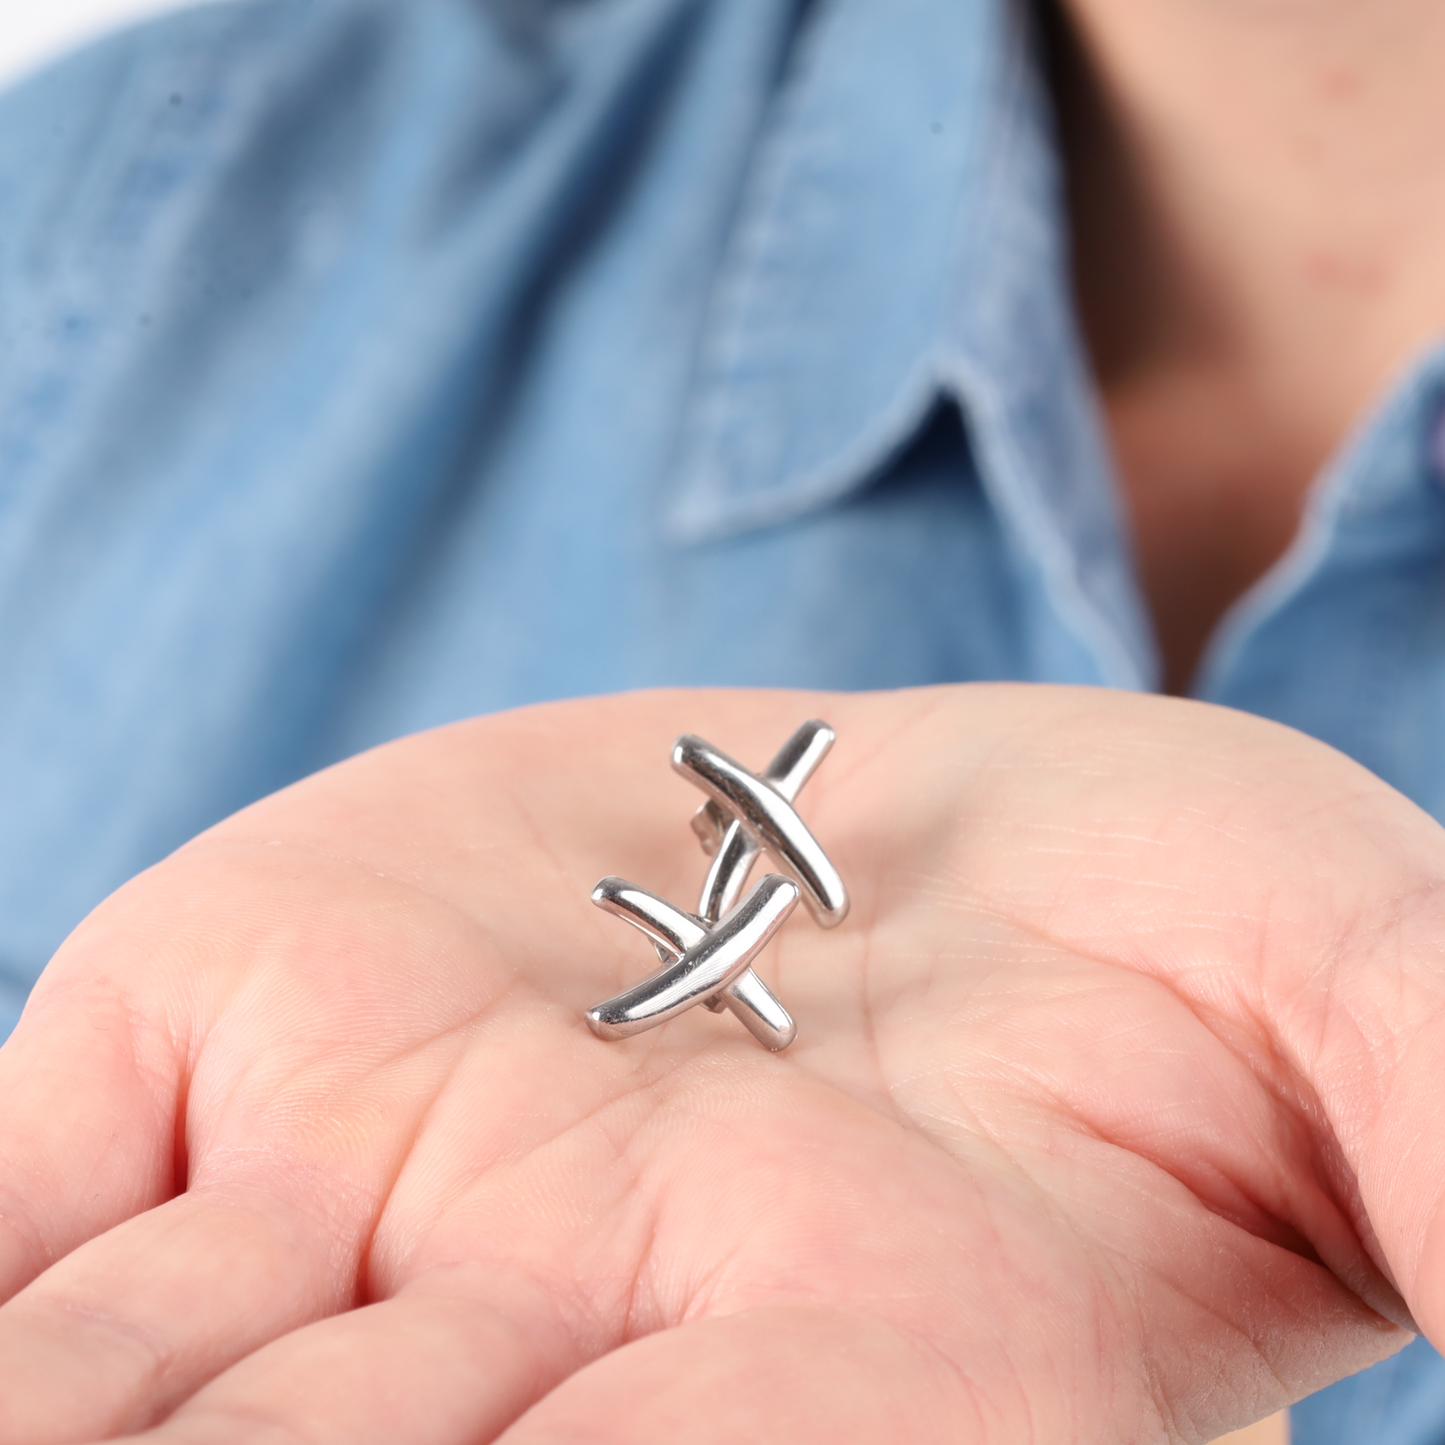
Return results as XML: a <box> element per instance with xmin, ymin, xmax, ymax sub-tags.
<box><xmin>668</xmin><ymin>0</ymin><xmax>1157</xmax><ymax>686</ymax></box>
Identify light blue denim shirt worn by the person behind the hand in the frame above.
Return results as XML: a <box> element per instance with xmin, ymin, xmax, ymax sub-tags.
<box><xmin>0</xmin><ymin>0</ymin><xmax>1445</xmax><ymax>1445</ymax></box>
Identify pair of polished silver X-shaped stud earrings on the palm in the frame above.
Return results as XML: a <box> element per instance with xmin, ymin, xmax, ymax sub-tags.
<box><xmin>587</xmin><ymin>720</ymin><xmax>848</xmax><ymax>1051</ymax></box>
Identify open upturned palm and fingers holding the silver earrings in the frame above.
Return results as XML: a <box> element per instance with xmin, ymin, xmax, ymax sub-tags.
<box><xmin>0</xmin><ymin>688</ymin><xmax>1445</xmax><ymax>1445</ymax></box>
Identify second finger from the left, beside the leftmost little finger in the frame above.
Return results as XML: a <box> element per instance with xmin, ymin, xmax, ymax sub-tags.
<box><xmin>0</xmin><ymin>1189</ymin><xmax>357</xmax><ymax>1445</ymax></box>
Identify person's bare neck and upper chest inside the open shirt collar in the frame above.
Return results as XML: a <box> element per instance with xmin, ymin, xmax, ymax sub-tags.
<box><xmin>1056</xmin><ymin>0</ymin><xmax>1445</xmax><ymax>685</ymax></box>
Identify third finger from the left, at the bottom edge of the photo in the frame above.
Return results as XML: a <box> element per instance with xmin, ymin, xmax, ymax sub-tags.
<box><xmin>109</xmin><ymin>1264</ymin><xmax>585</xmax><ymax>1445</ymax></box>
